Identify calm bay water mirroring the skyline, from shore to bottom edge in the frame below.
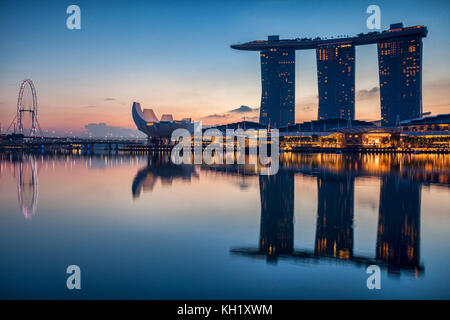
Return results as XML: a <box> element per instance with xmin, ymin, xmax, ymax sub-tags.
<box><xmin>0</xmin><ymin>153</ymin><xmax>450</xmax><ymax>299</ymax></box>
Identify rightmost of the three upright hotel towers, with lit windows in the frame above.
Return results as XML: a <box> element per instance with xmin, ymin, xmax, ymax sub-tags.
<box><xmin>377</xmin><ymin>23</ymin><xmax>423</xmax><ymax>126</ymax></box>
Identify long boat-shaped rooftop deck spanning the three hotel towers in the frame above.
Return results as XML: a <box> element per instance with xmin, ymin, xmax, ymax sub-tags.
<box><xmin>231</xmin><ymin>24</ymin><xmax>428</xmax><ymax>51</ymax></box>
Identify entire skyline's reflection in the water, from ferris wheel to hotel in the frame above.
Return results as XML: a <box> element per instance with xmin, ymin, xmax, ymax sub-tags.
<box><xmin>1</xmin><ymin>152</ymin><xmax>444</xmax><ymax>275</ymax></box>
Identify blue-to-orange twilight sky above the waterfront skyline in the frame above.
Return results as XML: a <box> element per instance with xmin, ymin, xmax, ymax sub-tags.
<box><xmin>0</xmin><ymin>0</ymin><xmax>450</xmax><ymax>132</ymax></box>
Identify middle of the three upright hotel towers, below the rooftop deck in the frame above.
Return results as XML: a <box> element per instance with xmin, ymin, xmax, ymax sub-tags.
<box><xmin>316</xmin><ymin>44</ymin><xmax>355</xmax><ymax>119</ymax></box>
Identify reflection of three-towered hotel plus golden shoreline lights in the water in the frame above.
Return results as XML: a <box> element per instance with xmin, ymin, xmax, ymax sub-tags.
<box><xmin>230</xmin><ymin>155</ymin><xmax>434</xmax><ymax>275</ymax></box>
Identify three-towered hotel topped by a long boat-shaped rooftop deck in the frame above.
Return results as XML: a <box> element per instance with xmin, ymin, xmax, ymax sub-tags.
<box><xmin>231</xmin><ymin>23</ymin><xmax>428</xmax><ymax>128</ymax></box>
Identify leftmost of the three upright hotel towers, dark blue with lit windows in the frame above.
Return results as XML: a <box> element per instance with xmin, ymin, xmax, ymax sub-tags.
<box><xmin>259</xmin><ymin>36</ymin><xmax>295</xmax><ymax>128</ymax></box>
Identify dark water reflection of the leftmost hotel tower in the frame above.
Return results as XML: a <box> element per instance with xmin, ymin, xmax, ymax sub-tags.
<box><xmin>259</xmin><ymin>171</ymin><xmax>294</xmax><ymax>261</ymax></box>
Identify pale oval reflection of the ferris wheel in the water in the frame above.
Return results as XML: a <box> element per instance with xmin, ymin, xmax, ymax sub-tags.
<box><xmin>17</xmin><ymin>156</ymin><xmax>38</xmax><ymax>219</ymax></box>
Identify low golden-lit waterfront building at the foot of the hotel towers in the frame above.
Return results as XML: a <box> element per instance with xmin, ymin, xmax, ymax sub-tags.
<box><xmin>279</xmin><ymin>114</ymin><xmax>450</xmax><ymax>153</ymax></box>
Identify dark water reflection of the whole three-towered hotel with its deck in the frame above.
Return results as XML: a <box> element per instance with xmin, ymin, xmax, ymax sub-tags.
<box><xmin>231</xmin><ymin>165</ymin><xmax>423</xmax><ymax>274</ymax></box>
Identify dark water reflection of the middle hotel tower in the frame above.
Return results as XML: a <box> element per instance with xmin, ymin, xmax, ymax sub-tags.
<box><xmin>314</xmin><ymin>173</ymin><xmax>354</xmax><ymax>259</ymax></box>
